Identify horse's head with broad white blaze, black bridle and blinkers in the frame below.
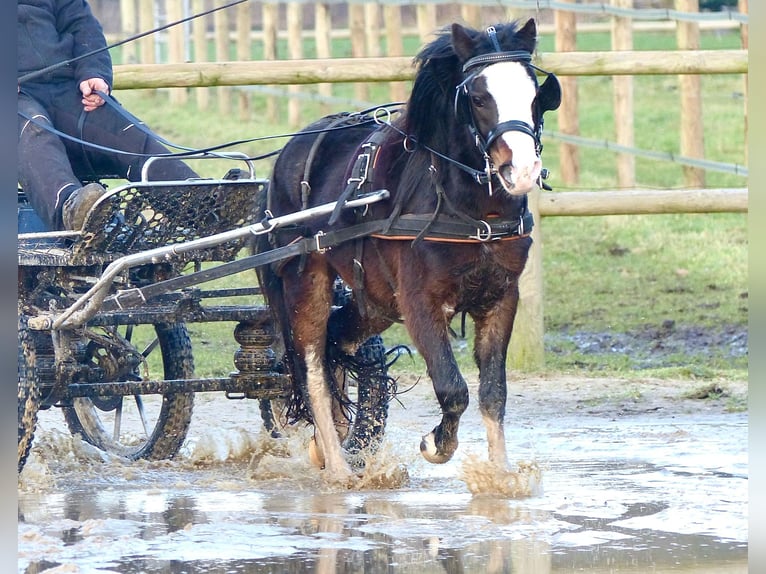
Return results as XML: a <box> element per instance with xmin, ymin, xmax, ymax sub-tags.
<box><xmin>452</xmin><ymin>19</ymin><xmax>561</xmax><ymax>195</ymax></box>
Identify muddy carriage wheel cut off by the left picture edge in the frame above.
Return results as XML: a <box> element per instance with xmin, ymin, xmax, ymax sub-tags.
<box><xmin>18</xmin><ymin>315</ymin><xmax>40</xmax><ymax>472</ymax></box>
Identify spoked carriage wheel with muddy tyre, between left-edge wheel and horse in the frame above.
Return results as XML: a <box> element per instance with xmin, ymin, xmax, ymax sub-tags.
<box><xmin>63</xmin><ymin>323</ymin><xmax>194</xmax><ymax>460</ymax></box>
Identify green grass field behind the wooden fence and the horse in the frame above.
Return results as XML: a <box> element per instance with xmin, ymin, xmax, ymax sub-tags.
<box><xmin>109</xmin><ymin>29</ymin><xmax>748</xmax><ymax>380</ymax></box>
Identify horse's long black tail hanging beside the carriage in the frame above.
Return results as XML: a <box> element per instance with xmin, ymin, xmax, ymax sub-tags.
<box><xmin>250</xmin><ymin>187</ymin><xmax>311</xmax><ymax>422</ymax></box>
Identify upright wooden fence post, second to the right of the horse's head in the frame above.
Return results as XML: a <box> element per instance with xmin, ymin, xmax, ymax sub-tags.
<box><xmin>612</xmin><ymin>0</ymin><xmax>636</xmax><ymax>188</ymax></box>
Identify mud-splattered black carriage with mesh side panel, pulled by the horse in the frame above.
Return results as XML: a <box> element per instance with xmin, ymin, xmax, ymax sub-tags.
<box><xmin>18</xmin><ymin>153</ymin><xmax>396</xmax><ymax>471</ymax></box>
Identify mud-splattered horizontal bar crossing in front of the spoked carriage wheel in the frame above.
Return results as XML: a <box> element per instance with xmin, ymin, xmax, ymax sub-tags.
<box><xmin>66</xmin><ymin>372</ymin><xmax>290</xmax><ymax>400</ymax></box>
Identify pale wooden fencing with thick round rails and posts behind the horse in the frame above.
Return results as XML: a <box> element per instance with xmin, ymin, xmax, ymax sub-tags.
<box><xmin>100</xmin><ymin>0</ymin><xmax>748</xmax><ymax>369</ymax></box>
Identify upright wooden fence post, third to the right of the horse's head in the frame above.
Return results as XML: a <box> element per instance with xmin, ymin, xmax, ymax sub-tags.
<box><xmin>676</xmin><ymin>0</ymin><xmax>705</xmax><ymax>188</ymax></box>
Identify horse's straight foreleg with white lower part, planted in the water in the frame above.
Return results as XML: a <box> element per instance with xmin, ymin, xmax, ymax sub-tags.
<box><xmin>474</xmin><ymin>298</ymin><xmax>516</xmax><ymax>467</ymax></box>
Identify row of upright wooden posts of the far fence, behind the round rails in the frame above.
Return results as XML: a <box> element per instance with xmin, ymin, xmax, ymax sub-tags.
<box><xmin>103</xmin><ymin>0</ymin><xmax>748</xmax><ymax>188</ymax></box>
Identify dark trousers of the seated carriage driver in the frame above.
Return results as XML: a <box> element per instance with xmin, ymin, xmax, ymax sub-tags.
<box><xmin>17</xmin><ymin>84</ymin><xmax>198</xmax><ymax>230</ymax></box>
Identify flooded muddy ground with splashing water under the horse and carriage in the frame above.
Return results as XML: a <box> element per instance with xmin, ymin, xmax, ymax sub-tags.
<box><xmin>18</xmin><ymin>376</ymin><xmax>748</xmax><ymax>574</ymax></box>
